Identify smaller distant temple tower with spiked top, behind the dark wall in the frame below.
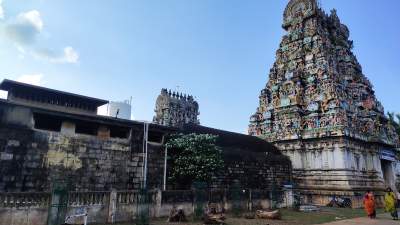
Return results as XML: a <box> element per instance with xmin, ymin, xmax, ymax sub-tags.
<box><xmin>153</xmin><ymin>89</ymin><xmax>200</xmax><ymax>127</ymax></box>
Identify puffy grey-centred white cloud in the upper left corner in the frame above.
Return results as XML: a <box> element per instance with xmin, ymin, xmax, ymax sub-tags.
<box><xmin>4</xmin><ymin>10</ymin><xmax>43</xmax><ymax>45</ymax></box>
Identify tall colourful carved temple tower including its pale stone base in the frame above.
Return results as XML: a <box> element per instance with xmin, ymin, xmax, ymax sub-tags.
<box><xmin>249</xmin><ymin>0</ymin><xmax>399</xmax><ymax>204</ymax></box>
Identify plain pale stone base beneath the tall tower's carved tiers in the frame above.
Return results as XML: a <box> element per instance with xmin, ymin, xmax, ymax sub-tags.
<box><xmin>275</xmin><ymin>137</ymin><xmax>396</xmax><ymax>208</ymax></box>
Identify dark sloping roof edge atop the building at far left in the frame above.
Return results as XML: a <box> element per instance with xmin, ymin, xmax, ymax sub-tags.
<box><xmin>0</xmin><ymin>79</ymin><xmax>108</xmax><ymax>107</ymax></box>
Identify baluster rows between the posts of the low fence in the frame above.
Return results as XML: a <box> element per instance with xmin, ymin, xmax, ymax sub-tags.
<box><xmin>0</xmin><ymin>189</ymin><xmax>283</xmax><ymax>208</ymax></box>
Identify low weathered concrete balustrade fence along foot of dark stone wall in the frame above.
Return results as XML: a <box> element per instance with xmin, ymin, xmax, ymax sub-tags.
<box><xmin>0</xmin><ymin>189</ymin><xmax>294</xmax><ymax>225</ymax></box>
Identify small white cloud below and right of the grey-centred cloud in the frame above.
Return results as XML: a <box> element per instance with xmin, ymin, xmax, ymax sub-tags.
<box><xmin>33</xmin><ymin>47</ymin><xmax>79</xmax><ymax>63</ymax></box>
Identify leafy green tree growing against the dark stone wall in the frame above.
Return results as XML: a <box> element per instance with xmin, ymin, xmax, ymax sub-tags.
<box><xmin>166</xmin><ymin>134</ymin><xmax>224</xmax><ymax>185</ymax></box>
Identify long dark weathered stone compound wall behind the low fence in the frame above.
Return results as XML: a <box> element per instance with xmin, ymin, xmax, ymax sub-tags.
<box><xmin>0</xmin><ymin>102</ymin><xmax>291</xmax><ymax>192</ymax></box>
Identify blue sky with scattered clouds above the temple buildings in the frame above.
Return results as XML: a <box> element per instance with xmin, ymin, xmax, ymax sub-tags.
<box><xmin>0</xmin><ymin>0</ymin><xmax>400</xmax><ymax>133</ymax></box>
